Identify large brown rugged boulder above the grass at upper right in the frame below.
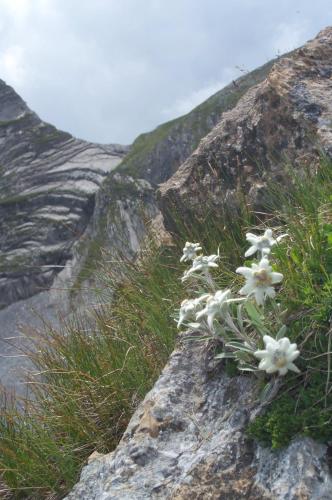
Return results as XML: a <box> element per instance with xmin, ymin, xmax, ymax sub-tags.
<box><xmin>160</xmin><ymin>28</ymin><xmax>332</xmax><ymax>227</ymax></box>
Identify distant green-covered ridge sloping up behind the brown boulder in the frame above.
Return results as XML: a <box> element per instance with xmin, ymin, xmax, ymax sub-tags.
<box><xmin>120</xmin><ymin>57</ymin><xmax>274</xmax><ymax>184</ymax></box>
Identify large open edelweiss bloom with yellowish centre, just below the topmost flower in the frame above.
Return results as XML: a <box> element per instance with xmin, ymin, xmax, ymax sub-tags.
<box><xmin>236</xmin><ymin>257</ymin><xmax>283</xmax><ymax>305</ymax></box>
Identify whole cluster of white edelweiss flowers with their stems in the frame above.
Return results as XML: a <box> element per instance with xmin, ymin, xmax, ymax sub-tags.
<box><xmin>177</xmin><ymin>229</ymin><xmax>300</xmax><ymax>376</ymax></box>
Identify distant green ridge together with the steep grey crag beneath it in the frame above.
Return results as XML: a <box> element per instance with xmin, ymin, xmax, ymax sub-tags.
<box><xmin>75</xmin><ymin>56</ymin><xmax>286</xmax><ymax>292</ymax></box>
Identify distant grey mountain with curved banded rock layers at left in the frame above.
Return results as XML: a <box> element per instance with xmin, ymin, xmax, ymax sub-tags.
<box><xmin>0</xmin><ymin>81</ymin><xmax>128</xmax><ymax>308</ymax></box>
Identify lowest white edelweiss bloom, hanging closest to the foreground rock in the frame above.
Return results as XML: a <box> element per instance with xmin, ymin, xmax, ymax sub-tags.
<box><xmin>254</xmin><ymin>335</ymin><xmax>300</xmax><ymax>375</ymax></box>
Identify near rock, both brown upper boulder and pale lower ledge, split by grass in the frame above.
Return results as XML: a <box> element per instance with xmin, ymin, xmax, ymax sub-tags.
<box><xmin>67</xmin><ymin>28</ymin><xmax>332</xmax><ymax>500</ymax></box>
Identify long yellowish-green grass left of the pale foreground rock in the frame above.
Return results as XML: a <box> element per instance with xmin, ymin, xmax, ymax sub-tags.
<box><xmin>0</xmin><ymin>240</ymin><xmax>184</xmax><ymax>499</ymax></box>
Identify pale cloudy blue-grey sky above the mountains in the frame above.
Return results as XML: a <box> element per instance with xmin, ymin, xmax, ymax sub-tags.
<box><xmin>0</xmin><ymin>0</ymin><xmax>332</xmax><ymax>144</ymax></box>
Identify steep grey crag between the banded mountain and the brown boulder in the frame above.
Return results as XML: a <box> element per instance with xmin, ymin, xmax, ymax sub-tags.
<box><xmin>68</xmin><ymin>171</ymin><xmax>160</xmax><ymax>307</ymax></box>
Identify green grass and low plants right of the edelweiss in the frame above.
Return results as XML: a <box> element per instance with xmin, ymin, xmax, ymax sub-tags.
<box><xmin>249</xmin><ymin>161</ymin><xmax>332</xmax><ymax>448</ymax></box>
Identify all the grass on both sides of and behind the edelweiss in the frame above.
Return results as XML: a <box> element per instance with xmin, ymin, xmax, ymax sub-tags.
<box><xmin>0</xmin><ymin>161</ymin><xmax>332</xmax><ymax>499</ymax></box>
